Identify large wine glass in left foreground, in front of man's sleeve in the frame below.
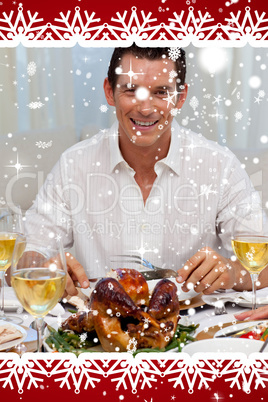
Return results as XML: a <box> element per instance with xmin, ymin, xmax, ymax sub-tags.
<box><xmin>11</xmin><ymin>235</ymin><xmax>67</xmax><ymax>352</ymax></box>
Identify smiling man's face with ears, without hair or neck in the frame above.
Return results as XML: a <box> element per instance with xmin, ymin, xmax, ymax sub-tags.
<box><xmin>104</xmin><ymin>54</ymin><xmax>187</xmax><ymax>147</ymax></box>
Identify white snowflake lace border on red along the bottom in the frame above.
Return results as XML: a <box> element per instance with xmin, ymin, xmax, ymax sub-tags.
<box><xmin>0</xmin><ymin>352</ymin><xmax>268</xmax><ymax>394</ymax></box>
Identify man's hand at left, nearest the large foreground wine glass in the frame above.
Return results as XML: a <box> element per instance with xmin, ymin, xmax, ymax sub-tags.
<box><xmin>65</xmin><ymin>252</ymin><xmax>89</xmax><ymax>296</ymax></box>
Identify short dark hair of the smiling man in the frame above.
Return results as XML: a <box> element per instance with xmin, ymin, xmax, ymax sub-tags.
<box><xmin>108</xmin><ymin>43</ymin><xmax>186</xmax><ymax>92</ymax></box>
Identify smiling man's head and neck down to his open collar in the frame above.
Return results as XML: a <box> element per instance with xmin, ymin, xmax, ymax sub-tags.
<box><xmin>104</xmin><ymin>47</ymin><xmax>187</xmax><ymax>203</ymax></box>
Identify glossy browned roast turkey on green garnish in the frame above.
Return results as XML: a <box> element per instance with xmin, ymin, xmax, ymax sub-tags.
<box><xmin>62</xmin><ymin>268</ymin><xmax>180</xmax><ymax>352</ymax></box>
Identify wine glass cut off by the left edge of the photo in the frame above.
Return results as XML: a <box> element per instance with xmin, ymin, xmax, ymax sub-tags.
<box><xmin>0</xmin><ymin>205</ymin><xmax>23</xmax><ymax>324</ymax></box>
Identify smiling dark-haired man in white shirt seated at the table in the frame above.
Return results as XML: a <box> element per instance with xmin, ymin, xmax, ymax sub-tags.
<box><xmin>23</xmin><ymin>44</ymin><xmax>266</xmax><ymax>295</ymax></box>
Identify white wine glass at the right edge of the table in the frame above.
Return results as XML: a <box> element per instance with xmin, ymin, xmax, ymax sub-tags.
<box><xmin>232</xmin><ymin>202</ymin><xmax>268</xmax><ymax>310</ymax></box>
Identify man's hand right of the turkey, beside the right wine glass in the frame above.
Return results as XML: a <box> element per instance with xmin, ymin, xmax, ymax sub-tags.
<box><xmin>177</xmin><ymin>247</ymin><xmax>241</xmax><ymax>294</ymax></box>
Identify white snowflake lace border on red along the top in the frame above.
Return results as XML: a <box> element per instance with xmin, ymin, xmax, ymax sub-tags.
<box><xmin>0</xmin><ymin>3</ymin><xmax>268</xmax><ymax>47</ymax></box>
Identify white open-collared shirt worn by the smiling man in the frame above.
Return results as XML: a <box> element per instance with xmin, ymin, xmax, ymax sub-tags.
<box><xmin>26</xmin><ymin>121</ymin><xmax>253</xmax><ymax>277</ymax></box>
